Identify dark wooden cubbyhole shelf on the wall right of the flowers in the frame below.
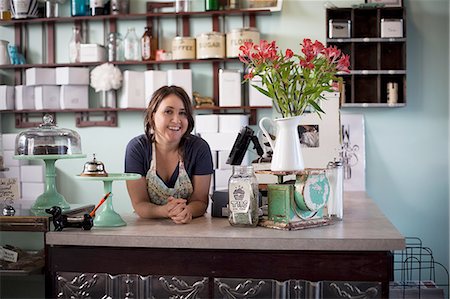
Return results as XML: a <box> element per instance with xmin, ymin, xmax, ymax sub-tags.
<box><xmin>326</xmin><ymin>7</ymin><xmax>406</xmax><ymax>107</ymax></box>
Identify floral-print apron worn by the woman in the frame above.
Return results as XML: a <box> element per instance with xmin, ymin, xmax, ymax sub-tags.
<box><xmin>146</xmin><ymin>143</ymin><xmax>194</xmax><ymax>205</ymax></box>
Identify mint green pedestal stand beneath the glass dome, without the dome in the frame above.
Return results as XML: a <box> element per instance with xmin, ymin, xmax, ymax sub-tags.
<box><xmin>14</xmin><ymin>154</ymin><xmax>86</xmax><ymax>215</ymax></box>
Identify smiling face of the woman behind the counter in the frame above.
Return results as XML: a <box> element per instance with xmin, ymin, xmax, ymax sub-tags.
<box><xmin>153</xmin><ymin>94</ymin><xmax>188</xmax><ymax>143</ymax></box>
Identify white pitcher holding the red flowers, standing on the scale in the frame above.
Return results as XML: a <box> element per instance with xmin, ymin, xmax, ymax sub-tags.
<box><xmin>259</xmin><ymin>116</ymin><xmax>305</xmax><ymax>171</ymax></box>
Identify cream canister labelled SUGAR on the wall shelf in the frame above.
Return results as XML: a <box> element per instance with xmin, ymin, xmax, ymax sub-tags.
<box><xmin>197</xmin><ymin>32</ymin><xmax>225</xmax><ymax>59</ymax></box>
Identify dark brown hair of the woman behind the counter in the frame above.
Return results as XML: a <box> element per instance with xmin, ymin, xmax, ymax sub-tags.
<box><xmin>144</xmin><ymin>85</ymin><xmax>194</xmax><ymax>147</ymax></box>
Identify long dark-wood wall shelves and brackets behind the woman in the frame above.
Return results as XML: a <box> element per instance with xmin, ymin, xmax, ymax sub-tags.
<box><xmin>0</xmin><ymin>7</ymin><xmax>271</xmax><ymax>128</ymax></box>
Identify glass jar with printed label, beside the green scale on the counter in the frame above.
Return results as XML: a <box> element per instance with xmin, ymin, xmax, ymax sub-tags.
<box><xmin>228</xmin><ymin>166</ymin><xmax>259</xmax><ymax>226</ymax></box>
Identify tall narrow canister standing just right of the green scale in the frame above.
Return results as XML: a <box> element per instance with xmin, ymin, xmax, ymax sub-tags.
<box><xmin>326</xmin><ymin>161</ymin><xmax>344</xmax><ymax>220</ymax></box>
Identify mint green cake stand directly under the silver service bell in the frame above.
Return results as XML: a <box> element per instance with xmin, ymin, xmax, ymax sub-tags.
<box><xmin>77</xmin><ymin>173</ymin><xmax>141</xmax><ymax>227</ymax></box>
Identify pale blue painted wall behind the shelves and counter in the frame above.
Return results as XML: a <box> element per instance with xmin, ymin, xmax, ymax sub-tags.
<box><xmin>0</xmin><ymin>0</ymin><xmax>449</xmax><ymax>288</ymax></box>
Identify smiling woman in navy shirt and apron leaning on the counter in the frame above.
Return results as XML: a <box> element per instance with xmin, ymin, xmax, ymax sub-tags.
<box><xmin>125</xmin><ymin>86</ymin><xmax>213</xmax><ymax>224</ymax></box>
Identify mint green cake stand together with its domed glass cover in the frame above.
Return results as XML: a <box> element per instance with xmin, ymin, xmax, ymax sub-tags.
<box><xmin>14</xmin><ymin>114</ymin><xmax>86</xmax><ymax>215</ymax></box>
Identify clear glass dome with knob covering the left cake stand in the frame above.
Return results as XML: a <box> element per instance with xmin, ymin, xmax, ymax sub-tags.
<box><xmin>16</xmin><ymin>114</ymin><xmax>81</xmax><ymax>155</ymax></box>
